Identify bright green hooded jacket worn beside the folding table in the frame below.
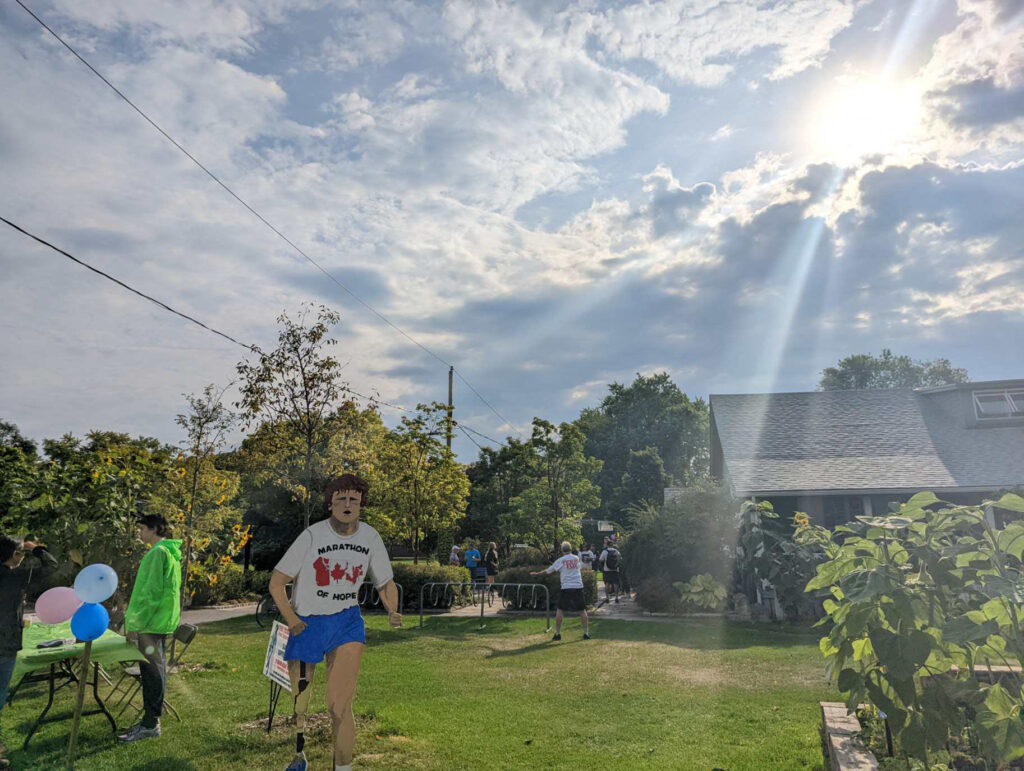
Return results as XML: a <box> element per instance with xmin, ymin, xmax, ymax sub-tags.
<box><xmin>125</xmin><ymin>539</ymin><xmax>181</xmax><ymax>635</ymax></box>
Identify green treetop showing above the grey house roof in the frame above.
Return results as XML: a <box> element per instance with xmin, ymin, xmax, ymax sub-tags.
<box><xmin>818</xmin><ymin>348</ymin><xmax>971</xmax><ymax>391</ymax></box>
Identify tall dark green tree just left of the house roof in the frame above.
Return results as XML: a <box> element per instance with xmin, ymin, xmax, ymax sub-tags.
<box><xmin>577</xmin><ymin>372</ymin><xmax>709</xmax><ymax>519</ymax></box>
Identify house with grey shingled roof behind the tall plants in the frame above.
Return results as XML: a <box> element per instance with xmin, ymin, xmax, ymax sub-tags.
<box><xmin>710</xmin><ymin>380</ymin><xmax>1024</xmax><ymax>526</ymax></box>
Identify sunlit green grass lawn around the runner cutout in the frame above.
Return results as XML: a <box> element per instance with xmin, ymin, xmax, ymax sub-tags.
<box><xmin>3</xmin><ymin>616</ymin><xmax>837</xmax><ymax>771</ymax></box>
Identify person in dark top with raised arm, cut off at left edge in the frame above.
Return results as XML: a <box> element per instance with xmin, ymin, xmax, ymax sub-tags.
<box><xmin>0</xmin><ymin>536</ymin><xmax>56</xmax><ymax>768</ymax></box>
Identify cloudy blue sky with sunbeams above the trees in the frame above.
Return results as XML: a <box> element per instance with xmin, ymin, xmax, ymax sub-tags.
<box><xmin>0</xmin><ymin>0</ymin><xmax>1024</xmax><ymax>461</ymax></box>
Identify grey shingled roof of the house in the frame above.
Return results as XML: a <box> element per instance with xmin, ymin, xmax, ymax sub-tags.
<box><xmin>711</xmin><ymin>383</ymin><xmax>1024</xmax><ymax>495</ymax></box>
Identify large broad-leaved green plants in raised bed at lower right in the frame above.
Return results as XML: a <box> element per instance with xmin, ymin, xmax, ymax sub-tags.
<box><xmin>807</xmin><ymin>492</ymin><xmax>1024</xmax><ymax>764</ymax></box>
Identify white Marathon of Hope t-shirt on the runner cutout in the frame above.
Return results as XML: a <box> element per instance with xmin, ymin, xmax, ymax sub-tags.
<box><xmin>274</xmin><ymin>519</ymin><xmax>394</xmax><ymax>615</ymax></box>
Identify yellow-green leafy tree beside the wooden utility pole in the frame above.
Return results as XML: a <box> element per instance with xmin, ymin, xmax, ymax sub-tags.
<box><xmin>367</xmin><ymin>402</ymin><xmax>469</xmax><ymax>563</ymax></box>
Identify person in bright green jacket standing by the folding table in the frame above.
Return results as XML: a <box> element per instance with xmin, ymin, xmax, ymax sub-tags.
<box><xmin>119</xmin><ymin>514</ymin><xmax>181</xmax><ymax>741</ymax></box>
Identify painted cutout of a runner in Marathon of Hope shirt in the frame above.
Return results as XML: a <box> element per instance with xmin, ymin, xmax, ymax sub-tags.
<box><xmin>270</xmin><ymin>474</ymin><xmax>401</xmax><ymax>771</ymax></box>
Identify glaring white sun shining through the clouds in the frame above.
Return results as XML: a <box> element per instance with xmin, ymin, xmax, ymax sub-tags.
<box><xmin>806</xmin><ymin>80</ymin><xmax>921</xmax><ymax>166</ymax></box>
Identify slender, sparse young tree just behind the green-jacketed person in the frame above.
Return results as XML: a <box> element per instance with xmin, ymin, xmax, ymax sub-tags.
<box><xmin>175</xmin><ymin>384</ymin><xmax>239</xmax><ymax>607</ymax></box>
